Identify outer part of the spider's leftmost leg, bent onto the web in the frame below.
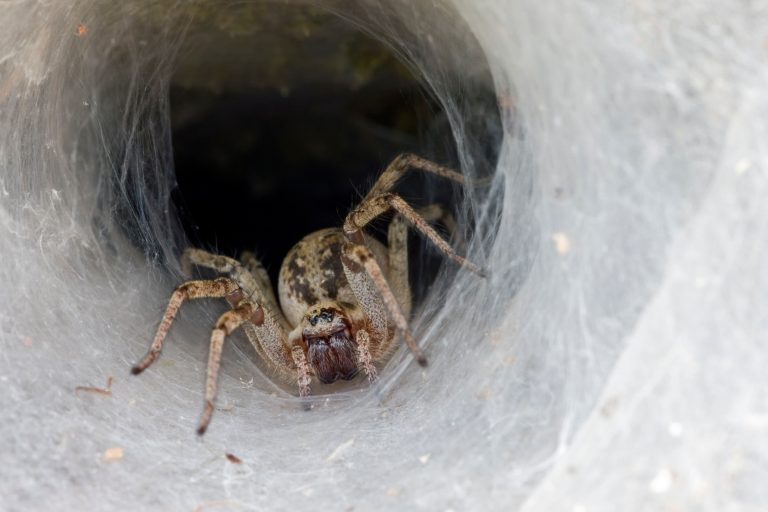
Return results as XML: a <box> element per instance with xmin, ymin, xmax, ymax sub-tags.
<box><xmin>131</xmin><ymin>277</ymin><xmax>240</xmax><ymax>375</ymax></box>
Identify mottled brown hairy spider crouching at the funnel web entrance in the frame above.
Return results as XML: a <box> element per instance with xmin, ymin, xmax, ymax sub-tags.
<box><xmin>132</xmin><ymin>154</ymin><xmax>484</xmax><ymax>435</ymax></box>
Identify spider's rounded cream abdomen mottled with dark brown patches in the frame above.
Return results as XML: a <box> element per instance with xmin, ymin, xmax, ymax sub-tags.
<box><xmin>277</xmin><ymin>228</ymin><xmax>388</xmax><ymax>326</ymax></box>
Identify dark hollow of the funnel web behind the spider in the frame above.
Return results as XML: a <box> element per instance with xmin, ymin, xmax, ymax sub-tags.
<box><xmin>170</xmin><ymin>6</ymin><xmax>498</xmax><ymax>299</ymax></box>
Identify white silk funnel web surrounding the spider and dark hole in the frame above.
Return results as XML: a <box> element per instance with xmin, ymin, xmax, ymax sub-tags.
<box><xmin>0</xmin><ymin>0</ymin><xmax>768</xmax><ymax>512</ymax></box>
